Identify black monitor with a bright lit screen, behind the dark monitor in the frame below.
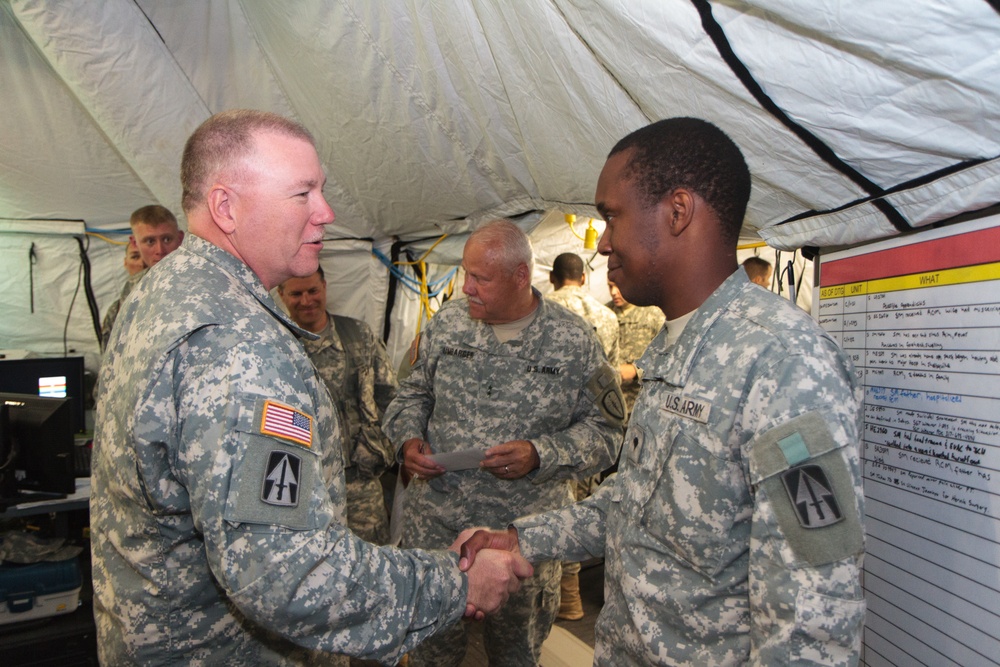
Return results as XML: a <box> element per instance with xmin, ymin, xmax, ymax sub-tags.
<box><xmin>0</xmin><ymin>357</ymin><xmax>86</xmax><ymax>432</ymax></box>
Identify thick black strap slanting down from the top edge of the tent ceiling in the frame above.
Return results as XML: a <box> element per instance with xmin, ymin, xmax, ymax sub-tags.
<box><xmin>691</xmin><ymin>0</ymin><xmax>912</xmax><ymax>232</ymax></box>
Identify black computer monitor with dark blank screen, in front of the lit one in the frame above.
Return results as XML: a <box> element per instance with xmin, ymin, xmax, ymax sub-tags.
<box><xmin>0</xmin><ymin>393</ymin><xmax>76</xmax><ymax>505</ymax></box>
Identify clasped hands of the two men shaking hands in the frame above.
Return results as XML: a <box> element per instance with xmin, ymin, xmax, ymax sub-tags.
<box><xmin>449</xmin><ymin>527</ymin><xmax>534</xmax><ymax>621</ymax></box>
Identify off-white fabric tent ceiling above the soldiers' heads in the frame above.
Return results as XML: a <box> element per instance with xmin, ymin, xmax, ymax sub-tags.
<box><xmin>0</xmin><ymin>0</ymin><xmax>1000</xmax><ymax>248</ymax></box>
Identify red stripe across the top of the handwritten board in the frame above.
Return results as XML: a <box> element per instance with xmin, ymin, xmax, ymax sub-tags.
<box><xmin>820</xmin><ymin>227</ymin><xmax>1000</xmax><ymax>287</ymax></box>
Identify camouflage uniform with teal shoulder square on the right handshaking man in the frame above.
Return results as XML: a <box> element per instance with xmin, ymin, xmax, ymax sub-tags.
<box><xmin>515</xmin><ymin>269</ymin><xmax>865</xmax><ymax>667</ymax></box>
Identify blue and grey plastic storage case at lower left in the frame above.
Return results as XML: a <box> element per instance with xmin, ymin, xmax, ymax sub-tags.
<box><xmin>0</xmin><ymin>558</ymin><xmax>81</xmax><ymax>625</ymax></box>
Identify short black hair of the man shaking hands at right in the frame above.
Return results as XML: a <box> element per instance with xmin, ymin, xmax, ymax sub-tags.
<box><xmin>608</xmin><ymin>118</ymin><xmax>750</xmax><ymax>243</ymax></box>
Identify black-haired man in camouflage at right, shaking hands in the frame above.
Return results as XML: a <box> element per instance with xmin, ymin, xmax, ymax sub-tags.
<box><xmin>463</xmin><ymin>118</ymin><xmax>865</xmax><ymax>667</ymax></box>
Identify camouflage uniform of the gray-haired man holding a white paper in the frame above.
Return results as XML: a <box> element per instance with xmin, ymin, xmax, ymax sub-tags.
<box><xmin>383</xmin><ymin>299</ymin><xmax>624</xmax><ymax>667</ymax></box>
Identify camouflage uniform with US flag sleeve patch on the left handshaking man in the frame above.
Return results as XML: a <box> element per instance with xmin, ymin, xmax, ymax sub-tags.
<box><xmin>91</xmin><ymin>236</ymin><xmax>467</xmax><ymax>665</ymax></box>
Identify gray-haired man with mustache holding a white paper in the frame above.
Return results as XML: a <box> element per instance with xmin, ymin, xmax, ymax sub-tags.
<box><xmin>383</xmin><ymin>220</ymin><xmax>624</xmax><ymax>667</ymax></box>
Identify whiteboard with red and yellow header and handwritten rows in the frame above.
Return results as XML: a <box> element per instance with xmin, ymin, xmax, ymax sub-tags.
<box><xmin>813</xmin><ymin>215</ymin><xmax>1000</xmax><ymax>667</ymax></box>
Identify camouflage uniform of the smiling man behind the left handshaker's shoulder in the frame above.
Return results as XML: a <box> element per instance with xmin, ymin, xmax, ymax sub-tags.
<box><xmin>302</xmin><ymin>313</ymin><xmax>396</xmax><ymax>544</ymax></box>
